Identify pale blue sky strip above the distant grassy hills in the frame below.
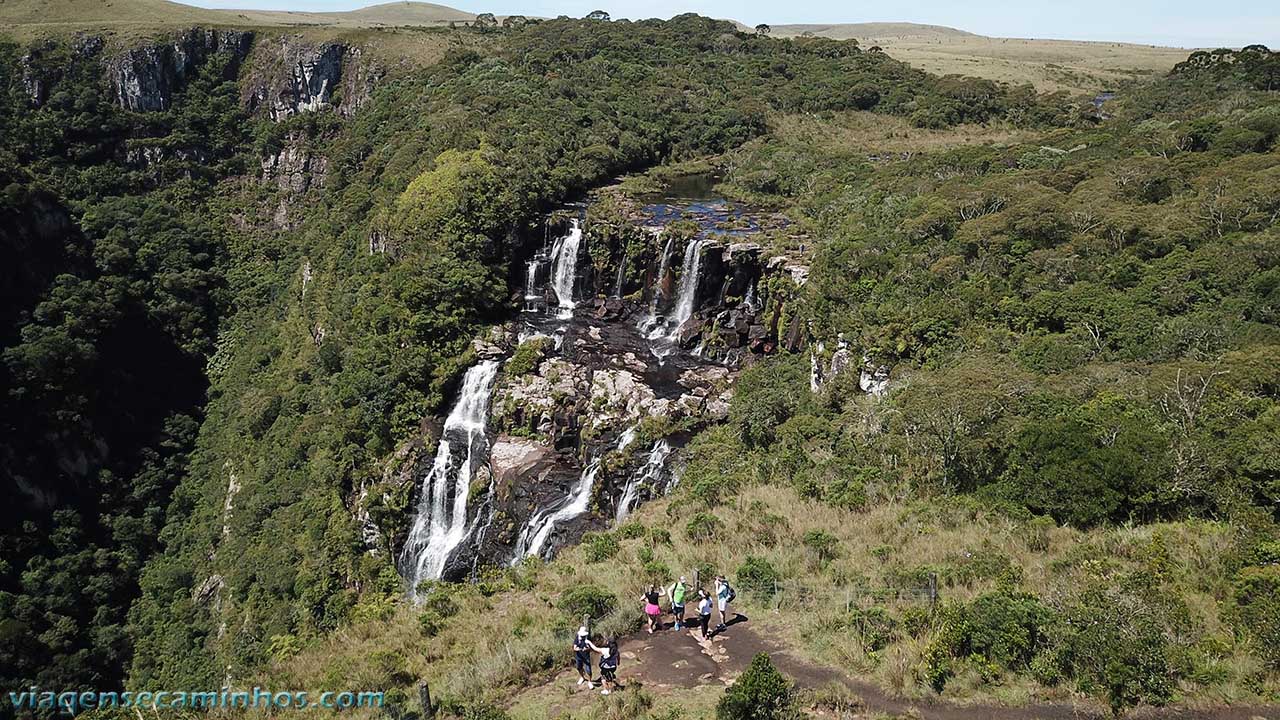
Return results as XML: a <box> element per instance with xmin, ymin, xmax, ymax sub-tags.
<box><xmin>182</xmin><ymin>0</ymin><xmax>1280</xmax><ymax>49</ymax></box>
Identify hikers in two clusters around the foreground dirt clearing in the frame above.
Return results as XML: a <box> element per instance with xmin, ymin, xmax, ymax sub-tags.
<box><xmin>573</xmin><ymin>575</ymin><xmax>737</xmax><ymax>694</ymax></box>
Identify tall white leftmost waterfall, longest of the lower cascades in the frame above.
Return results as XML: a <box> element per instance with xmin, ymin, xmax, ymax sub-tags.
<box><xmin>399</xmin><ymin>360</ymin><xmax>498</xmax><ymax>596</ymax></box>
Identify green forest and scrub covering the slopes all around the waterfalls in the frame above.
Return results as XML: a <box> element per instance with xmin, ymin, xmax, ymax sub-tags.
<box><xmin>0</xmin><ymin>15</ymin><xmax>1280</xmax><ymax>720</ymax></box>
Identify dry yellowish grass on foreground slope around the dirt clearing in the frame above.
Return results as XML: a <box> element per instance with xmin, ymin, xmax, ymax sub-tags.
<box><xmin>270</xmin><ymin>476</ymin><xmax>1249</xmax><ymax>717</ymax></box>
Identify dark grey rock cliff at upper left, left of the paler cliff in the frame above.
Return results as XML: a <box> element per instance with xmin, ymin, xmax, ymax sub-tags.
<box><xmin>108</xmin><ymin>28</ymin><xmax>253</xmax><ymax>113</ymax></box>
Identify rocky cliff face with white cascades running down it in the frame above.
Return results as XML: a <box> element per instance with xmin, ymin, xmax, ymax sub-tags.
<box><xmin>376</xmin><ymin>188</ymin><xmax>824</xmax><ymax>580</ymax></box>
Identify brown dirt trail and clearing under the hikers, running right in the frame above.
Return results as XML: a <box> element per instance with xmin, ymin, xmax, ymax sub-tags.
<box><xmin>524</xmin><ymin>614</ymin><xmax>1280</xmax><ymax>720</ymax></box>
